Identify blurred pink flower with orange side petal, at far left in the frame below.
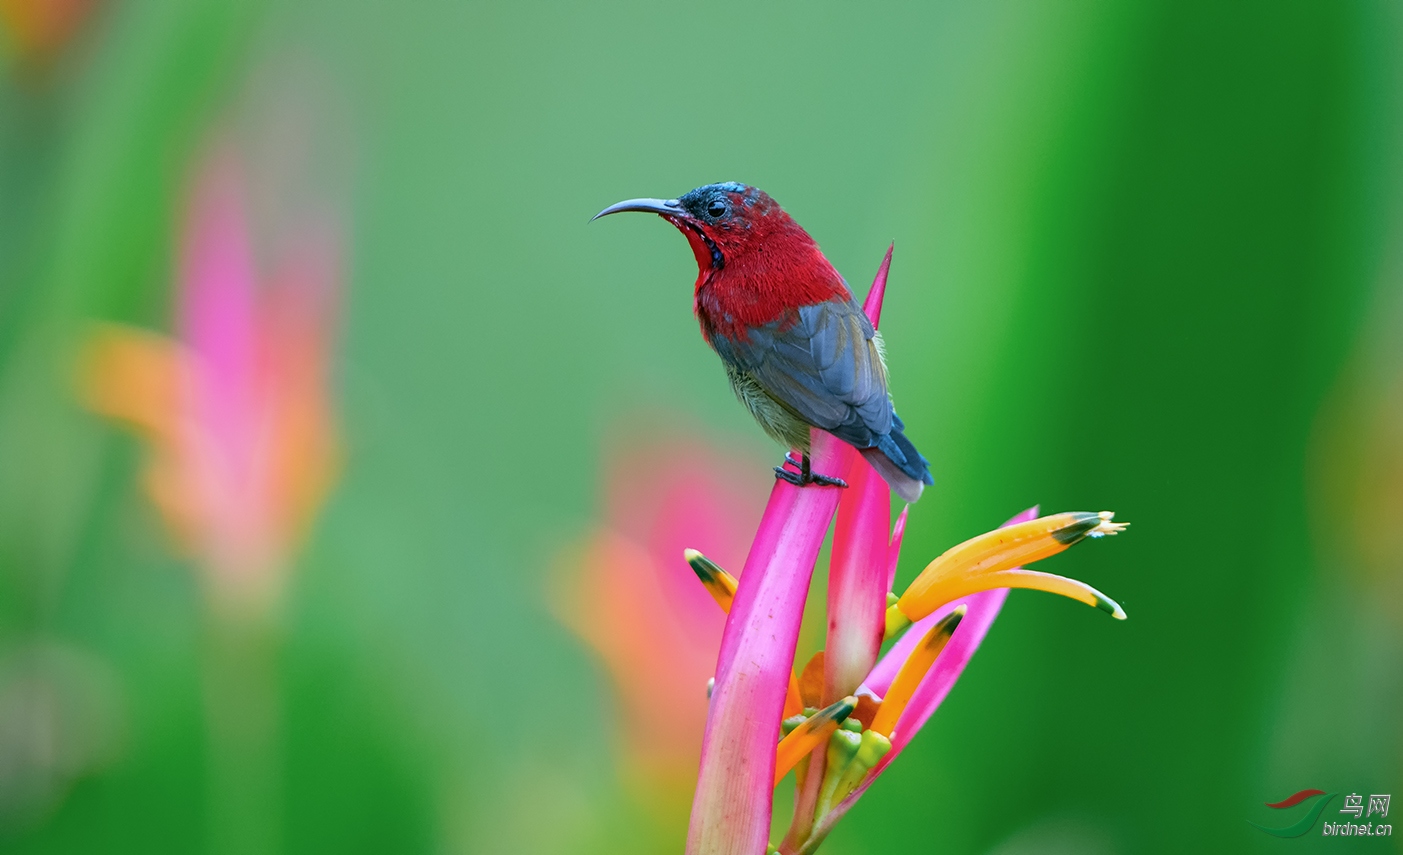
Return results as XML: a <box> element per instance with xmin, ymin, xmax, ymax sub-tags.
<box><xmin>80</xmin><ymin>147</ymin><xmax>338</xmax><ymax>608</ymax></box>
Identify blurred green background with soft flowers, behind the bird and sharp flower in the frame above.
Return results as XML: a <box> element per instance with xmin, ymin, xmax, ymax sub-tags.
<box><xmin>0</xmin><ymin>0</ymin><xmax>1403</xmax><ymax>855</ymax></box>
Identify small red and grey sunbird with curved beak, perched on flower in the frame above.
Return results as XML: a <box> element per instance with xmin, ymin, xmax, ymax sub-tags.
<box><xmin>591</xmin><ymin>181</ymin><xmax>934</xmax><ymax>503</ymax></box>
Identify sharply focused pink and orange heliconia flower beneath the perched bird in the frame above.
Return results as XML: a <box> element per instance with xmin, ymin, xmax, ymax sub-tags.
<box><xmin>686</xmin><ymin>250</ymin><xmax>1125</xmax><ymax>855</ymax></box>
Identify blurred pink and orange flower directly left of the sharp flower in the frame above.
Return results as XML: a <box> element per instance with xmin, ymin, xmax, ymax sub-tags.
<box><xmin>550</xmin><ymin>435</ymin><xmax>763</xmax><ymax>803</ymax></box>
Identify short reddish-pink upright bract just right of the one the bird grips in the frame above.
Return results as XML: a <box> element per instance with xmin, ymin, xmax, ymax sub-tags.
<box><xmin>824</xmin><ymin>455</ymin><xmax>891</xmax><ymax>705</ymax></box>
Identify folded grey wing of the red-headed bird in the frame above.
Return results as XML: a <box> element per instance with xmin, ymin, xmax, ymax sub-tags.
<box><xmin>713</xmin><ymin>298</ymin><xmax>892</xmax><ymax>448</ymax></box>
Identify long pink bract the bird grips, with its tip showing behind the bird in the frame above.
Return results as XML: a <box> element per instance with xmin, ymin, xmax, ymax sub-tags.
<box><xmin>686</xmin><ymin>250</ymin><xmax>891</xmax><ymax>855</ymax></box>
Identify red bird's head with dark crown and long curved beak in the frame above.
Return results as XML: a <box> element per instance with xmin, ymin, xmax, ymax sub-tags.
<box><xmin>593</xmin><ymin>181</ymin><xmax>822</xmax><ymax>288</ymax></box>
